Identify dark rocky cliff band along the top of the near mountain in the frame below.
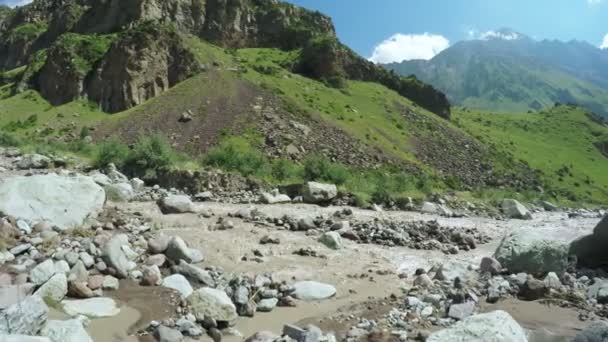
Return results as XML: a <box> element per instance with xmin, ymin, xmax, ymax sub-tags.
<box><xmin>0</xmin><ymin>0</ymin><xmax>449</xmax><ymax>118</ymax></box>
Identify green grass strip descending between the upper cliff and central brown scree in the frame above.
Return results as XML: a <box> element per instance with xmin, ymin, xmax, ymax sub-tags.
<box><xmin>238</xmin><ymin>49</ymin><xmax>450</xmax><ymax>166</ymax></box>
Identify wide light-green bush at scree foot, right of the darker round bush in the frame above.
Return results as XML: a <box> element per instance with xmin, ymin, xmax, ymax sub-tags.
<box><xmin>203</xmin><ymin>137</ymin><xmax>268</xmax><ymax>177</ymax></box>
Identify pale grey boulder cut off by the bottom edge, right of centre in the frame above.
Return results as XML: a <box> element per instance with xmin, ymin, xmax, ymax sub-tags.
<box><xmin>426</xmin><ymin>311</ymin><xmax>528</xmax><ymax>342</ymax></box>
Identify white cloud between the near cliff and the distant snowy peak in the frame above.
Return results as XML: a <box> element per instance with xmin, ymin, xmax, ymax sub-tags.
<box><xmin>369</xmin><ymin>33</ymin><xmax>450</xmax><ymax>63</ymax></box>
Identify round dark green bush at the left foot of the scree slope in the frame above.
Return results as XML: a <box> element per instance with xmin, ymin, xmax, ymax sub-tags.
<box><xmin>124</xmin><ymin>134</ymin><xmax>179</xmax><ymax>179</ymax></box>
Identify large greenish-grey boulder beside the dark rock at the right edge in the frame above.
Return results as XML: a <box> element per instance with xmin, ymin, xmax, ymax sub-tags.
<box><xmin>494</xmin><ymin>228</ymin><xmax>569</xmax><ymax>274</ymax></box>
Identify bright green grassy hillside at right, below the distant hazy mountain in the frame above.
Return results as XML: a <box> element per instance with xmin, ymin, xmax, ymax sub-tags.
<box><xmin>454</xmin><ymin>106</ymin><xmax>608</xmax><ymax>203</ymax></box>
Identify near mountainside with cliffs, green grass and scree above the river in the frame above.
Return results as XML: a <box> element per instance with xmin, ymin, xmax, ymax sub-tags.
<box><xmin>0</xmin><ymin>4</ymin><xmax>608</xmax><ymax>203</ymax></box>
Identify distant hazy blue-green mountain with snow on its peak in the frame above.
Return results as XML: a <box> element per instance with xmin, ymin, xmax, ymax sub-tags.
<box><xmin>385</xmin><ymin>29</ymin><xmax>608</xmax><ymax>116</ymax></box>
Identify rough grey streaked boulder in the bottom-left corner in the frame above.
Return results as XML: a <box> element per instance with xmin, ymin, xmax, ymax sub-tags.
<box><xmin>0</xmin><ymin>296</ymin><xmax>49</xmax><ymax>335</ymax></box>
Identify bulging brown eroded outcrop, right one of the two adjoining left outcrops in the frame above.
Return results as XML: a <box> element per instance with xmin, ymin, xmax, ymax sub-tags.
<box><xmin>86</xmin><ymin>24</ymin><xmax>200</xmax><ymax>113</ymax></box>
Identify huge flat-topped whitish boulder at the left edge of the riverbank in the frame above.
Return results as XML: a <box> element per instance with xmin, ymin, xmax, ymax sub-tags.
<box><xmin>0</xmin><ymin>174</ymin><xmax>106</xmax><ymax>229</ymax></box>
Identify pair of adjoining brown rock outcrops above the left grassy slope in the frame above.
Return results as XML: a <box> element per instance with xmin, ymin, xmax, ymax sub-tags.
<box><xmin>33</xmin><ymin>22</ymin><xmax>200</xmax><ymax>113</ymax></box>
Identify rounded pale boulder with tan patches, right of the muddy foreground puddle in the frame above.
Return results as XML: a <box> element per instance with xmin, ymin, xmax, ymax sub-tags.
<box><xmin>187</xmin><ymin>287</ymin><xmax>238</xmax><ymax>324</ymax></box>
